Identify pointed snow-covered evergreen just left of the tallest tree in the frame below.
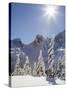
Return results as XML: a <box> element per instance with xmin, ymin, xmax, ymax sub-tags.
<box><xmin>36</xmin><ymin>50</ymin><xmax>45</xmax><ymax>76</ymax></box>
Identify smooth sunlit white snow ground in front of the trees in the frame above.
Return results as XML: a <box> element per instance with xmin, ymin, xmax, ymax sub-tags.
<box><xmin>11</xmin><ymin>75</ymin><xmax>65</xmax><ymax>87</ymax></box>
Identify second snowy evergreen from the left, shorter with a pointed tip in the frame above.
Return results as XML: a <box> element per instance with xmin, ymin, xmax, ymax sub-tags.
<box><xmin>23</xmin><ymin>56</ymin><xmax>31</xmax><ymax>75</ymax></box>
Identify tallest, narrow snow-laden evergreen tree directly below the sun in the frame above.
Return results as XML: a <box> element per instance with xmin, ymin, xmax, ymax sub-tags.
<box><xmin>48</xmin><ymin>38</ymin><xmax>56</xmax><ymax>76</ymax></box>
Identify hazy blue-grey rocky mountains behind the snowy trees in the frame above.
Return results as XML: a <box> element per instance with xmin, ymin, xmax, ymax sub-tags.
<box><xmin>10</xmin><ymin>31</ymin><xmax>65</xmax><ymax>73</ymax></box>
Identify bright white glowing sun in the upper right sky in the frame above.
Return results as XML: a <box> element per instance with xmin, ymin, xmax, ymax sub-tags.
<box><xmin>44</xmin><ymin>6</ymin><xmax>58</xmax><ymax>19</ymax></box>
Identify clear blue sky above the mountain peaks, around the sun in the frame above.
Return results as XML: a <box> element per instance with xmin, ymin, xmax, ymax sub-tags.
<box><xmin>11</xmin><ymin>3</ymin><xmax>65</xmax><ymax>44</ymax></box>
